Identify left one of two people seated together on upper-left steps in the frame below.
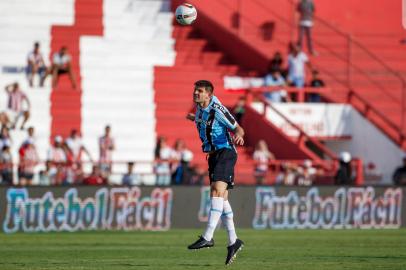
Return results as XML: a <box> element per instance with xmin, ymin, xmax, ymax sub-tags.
<box><xmin>27</xmin><ymin>42</ymin><xmax>47</xmax><ymax>87</ymax></box>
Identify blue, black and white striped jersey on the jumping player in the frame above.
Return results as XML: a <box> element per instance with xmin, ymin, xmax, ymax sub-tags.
<box><xmin>195</xmin><ymin>96</ymin><xmax>237</xmax><ymax>152</ymax></box>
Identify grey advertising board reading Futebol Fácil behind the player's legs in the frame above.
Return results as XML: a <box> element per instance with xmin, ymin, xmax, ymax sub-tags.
<box><xmin>0</xmin><ymin>186</ymin><xmax>406</xmax><ymax>233</ymax></box>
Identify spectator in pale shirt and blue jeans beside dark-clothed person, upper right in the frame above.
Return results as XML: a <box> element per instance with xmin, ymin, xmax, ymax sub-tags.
<box><xmin>288</xmin><ymin>43</ymin><xmax>312</xmax><ymax>88</ymax></box>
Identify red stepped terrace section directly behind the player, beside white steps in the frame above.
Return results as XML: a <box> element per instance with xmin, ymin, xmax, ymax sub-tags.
<box><xmin>154</xmin><ymin>25</ymin><xmax>254</xmax><ymax>184</ymax></box>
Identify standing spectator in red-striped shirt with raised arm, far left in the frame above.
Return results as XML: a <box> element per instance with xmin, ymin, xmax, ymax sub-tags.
<box><xmin>5</xmin><ymin>83</ymin><xmax>31</xmax><ymax>129</ymax></box>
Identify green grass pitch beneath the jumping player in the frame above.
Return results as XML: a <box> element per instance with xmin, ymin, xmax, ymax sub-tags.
<box><xmin>0</xmin><ymin>230</ymin><xmax>406</xmax><ymax>270</ymax></box>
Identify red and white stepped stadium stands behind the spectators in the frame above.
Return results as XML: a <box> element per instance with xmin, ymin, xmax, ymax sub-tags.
<box><xmin>0</xmin><ymin>0</ymin><xmax>406</xmax><ymax>184</ymax></box>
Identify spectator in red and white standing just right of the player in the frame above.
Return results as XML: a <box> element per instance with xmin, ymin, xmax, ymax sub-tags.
<box><xmin>253</xmin><ymin>140</ymin><xmax>275</xmax><ymax>185</ymax></box>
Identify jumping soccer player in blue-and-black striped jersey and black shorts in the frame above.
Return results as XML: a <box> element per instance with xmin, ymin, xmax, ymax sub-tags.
<box><xmin>186</xmin><ymin>80</ymin><xmax>244</xmax><ymax>265</ymax></box>
